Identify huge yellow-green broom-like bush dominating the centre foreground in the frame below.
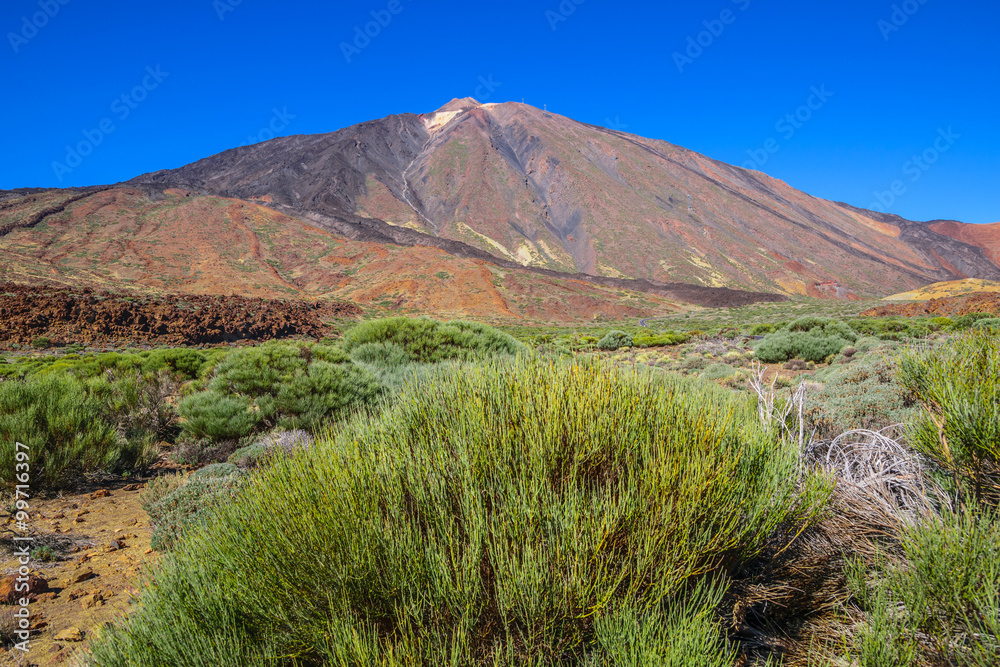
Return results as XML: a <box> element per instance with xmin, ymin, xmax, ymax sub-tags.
<box><xmin>93</xmin><ymin>360</ymin><xmax>828</xmax><ymax>667</ymax></box>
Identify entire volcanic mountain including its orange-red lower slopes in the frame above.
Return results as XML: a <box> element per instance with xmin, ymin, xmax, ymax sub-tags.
<box><xmin>0</xmin><ymin>99</ymin><xmax>1000</xmax><ymax>321</ymax></box>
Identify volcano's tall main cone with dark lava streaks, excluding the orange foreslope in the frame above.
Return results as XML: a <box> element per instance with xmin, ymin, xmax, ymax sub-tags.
<box><xmin>128</xmin><ymin>99</ymin><xmax>1000</xmax><ymax>296</ymax></box>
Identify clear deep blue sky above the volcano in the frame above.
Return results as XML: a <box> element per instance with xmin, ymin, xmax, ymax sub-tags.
<box><xmin>0</xmin><ymin>0</ymin><xmax>1000</xmax><ymax>223</ymax></box>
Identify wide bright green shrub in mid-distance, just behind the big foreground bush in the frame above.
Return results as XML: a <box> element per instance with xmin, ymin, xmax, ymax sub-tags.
<box><xmin>344</xmin><ymin>317</ymin><xmax>524</xmax><ymax>363</ymax></box>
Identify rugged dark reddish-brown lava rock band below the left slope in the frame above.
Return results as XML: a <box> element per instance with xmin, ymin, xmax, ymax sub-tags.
<box><xmin>0</xmin><ymin>283</ymin><xmax>361</xmax><ymax>347</ymax></box>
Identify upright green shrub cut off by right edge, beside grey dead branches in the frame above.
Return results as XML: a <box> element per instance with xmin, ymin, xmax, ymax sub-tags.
<box><xmin>899</xmin><ymin>330</ymin><xmax>1000</xmax><ymax>505</ymax></box>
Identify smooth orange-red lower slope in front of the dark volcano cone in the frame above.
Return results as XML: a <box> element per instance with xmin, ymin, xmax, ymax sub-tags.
<box><xmin>0</xmin><ymin>188</ymin><xmax>712</xmax><ymax>322</ymax></box>
